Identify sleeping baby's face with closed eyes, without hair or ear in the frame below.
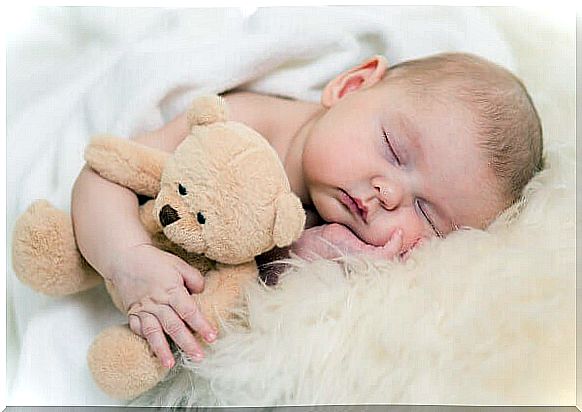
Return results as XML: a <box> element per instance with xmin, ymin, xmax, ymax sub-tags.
<box><xmin>303</xmin><ymin>82</ymin><xmax>502</xmax><ymax>252</ymax></box>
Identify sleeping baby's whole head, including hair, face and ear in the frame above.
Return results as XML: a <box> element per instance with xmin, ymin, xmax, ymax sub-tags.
<box><xmin>303</xmin><ymin>53</ymin><xmax>543</xmax><ymax>249</ymax></box>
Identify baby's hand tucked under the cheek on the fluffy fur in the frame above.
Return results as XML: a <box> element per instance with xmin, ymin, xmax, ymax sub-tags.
<box><xmin>291</xmin><ymin>223</ymin><xmax>402</xmax><ymax>260</ymax></box>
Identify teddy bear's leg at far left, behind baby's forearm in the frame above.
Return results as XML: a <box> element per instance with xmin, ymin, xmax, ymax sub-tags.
<box><xmin>12</xmin><ymin>200</ymin><xmax>102</xmax><ymax>296</ymax></box>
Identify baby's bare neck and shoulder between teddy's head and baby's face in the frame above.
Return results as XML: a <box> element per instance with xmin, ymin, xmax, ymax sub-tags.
<box><xmin>224</xmin><ymin>92</ymin><xmax>323</xmax><ymax>205</ymax></box>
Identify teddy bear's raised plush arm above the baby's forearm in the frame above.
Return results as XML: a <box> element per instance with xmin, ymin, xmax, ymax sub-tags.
<box><xmin>85</xmin><ymin>136</ymin><xmax>170</xmax><ymax>197</ymax></box>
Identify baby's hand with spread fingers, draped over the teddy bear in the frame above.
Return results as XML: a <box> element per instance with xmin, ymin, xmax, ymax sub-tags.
<box><xmin>108</xmin><ymin>244</ymin><xmax>217</xmax><ymax>368</ymax></box>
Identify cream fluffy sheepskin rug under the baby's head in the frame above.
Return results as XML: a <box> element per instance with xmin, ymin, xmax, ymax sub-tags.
<box><xmin>138</xmin><ymin>141</ymin><xmax>575</xmax><ymax>406</ymax></box>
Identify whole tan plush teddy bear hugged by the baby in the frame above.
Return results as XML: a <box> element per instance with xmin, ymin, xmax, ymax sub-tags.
<box><xmin>12</xmin><ymin>96</ymin><xmax>305</xmax><ymax>399</ymax></box>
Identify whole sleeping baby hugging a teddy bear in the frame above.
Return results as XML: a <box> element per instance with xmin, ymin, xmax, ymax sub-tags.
<box><xmin>71</xmin><ymin>53</ymin><xmax>543</xmax><ymax>368</ymax></box>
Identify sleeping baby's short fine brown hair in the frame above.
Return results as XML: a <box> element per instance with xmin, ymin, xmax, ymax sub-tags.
<box><xmin>386</xmin><ymin>53</ymin><xmax>544</xmax><ymax>206</ymax></box>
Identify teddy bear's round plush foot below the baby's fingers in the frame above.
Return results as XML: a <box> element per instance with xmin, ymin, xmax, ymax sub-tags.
<box><xmin>88</xmin><ymin>326</ymin><xmax>168</xmax><ymax>400</ymax></box>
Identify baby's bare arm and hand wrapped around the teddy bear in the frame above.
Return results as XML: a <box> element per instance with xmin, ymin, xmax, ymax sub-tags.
<box><xmin>71</xmin><ymin>114</ymin><xmax>216</xmax><ymax>367</ymax></box>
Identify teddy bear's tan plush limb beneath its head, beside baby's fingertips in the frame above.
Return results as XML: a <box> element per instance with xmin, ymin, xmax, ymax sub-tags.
<box><xmin>198</xmin><ymin>260</ymin><xmax>258</xmax><ymax>327</ymax></box>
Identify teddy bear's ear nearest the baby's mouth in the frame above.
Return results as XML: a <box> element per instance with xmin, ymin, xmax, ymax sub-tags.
<box><xmin>273</xmin><ymin>193</ymin><xmax>305</xmax><ymax>247</ymax></box>
